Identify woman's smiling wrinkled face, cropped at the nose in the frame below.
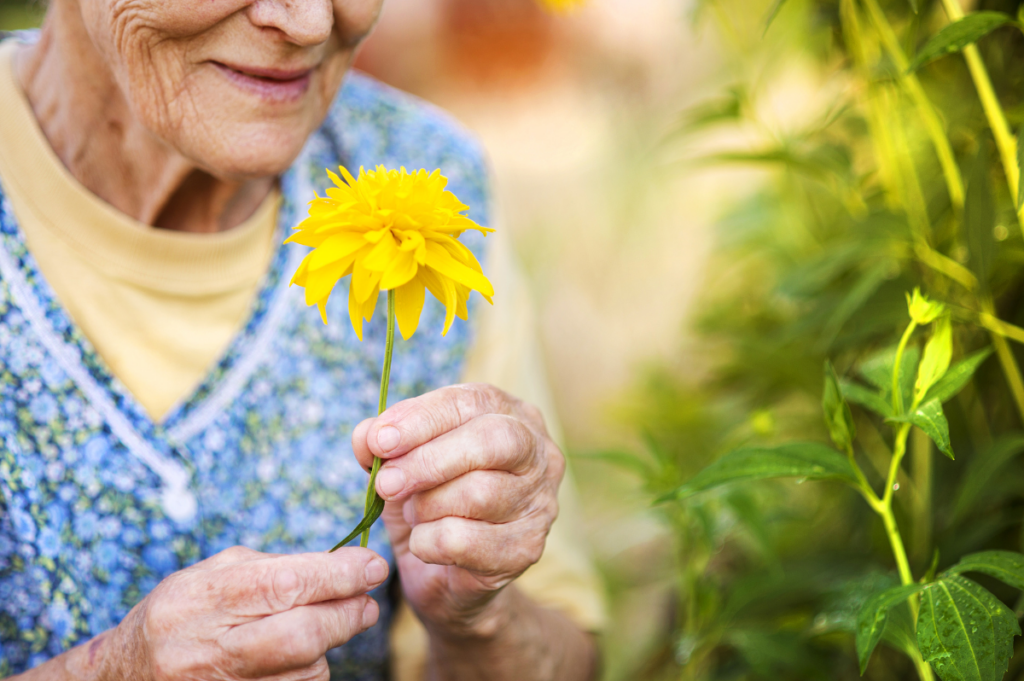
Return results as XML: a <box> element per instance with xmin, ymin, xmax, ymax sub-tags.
<box><xmin>79</xmin><ymin>0</ymin><xmax>383</xmax><ymax>178</ymax></box>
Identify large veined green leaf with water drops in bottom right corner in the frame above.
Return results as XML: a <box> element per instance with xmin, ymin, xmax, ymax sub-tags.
<box><xmin>918</xmin><ymin>574</ymin><xmax>1021</xmax><ymax>681</ymax></box>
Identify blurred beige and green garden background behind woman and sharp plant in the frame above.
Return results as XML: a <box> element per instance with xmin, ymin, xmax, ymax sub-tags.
<box><xmin>9</xmin><ymin>0</ymin><xmax>1024</xmax><ymax>681</ymax></box>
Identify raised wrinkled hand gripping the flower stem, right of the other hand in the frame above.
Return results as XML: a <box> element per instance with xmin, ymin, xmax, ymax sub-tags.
<box><xmin>352</xmin><ymin>384</ymin><xmax>565</xmax><ymax>638</ymax></box>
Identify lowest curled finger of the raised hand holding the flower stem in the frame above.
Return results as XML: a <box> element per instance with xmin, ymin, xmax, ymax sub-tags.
<box><xmin>409</xmin><ymin>513</ymin><xmax>553</xmax><ymax>577</ymax></box>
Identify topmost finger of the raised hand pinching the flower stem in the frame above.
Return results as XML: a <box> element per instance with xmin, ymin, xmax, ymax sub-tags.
<box><xmin>366</xmin><ymin>383</ymin><xmax>516</xmax><ymax>459</ymax></box>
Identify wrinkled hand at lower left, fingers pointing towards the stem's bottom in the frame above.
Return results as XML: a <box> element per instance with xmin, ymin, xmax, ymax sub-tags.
<box><xmin>25</xmin><ymin>547</ymin><xmax>388</xmax><ymax>681</ymax></box>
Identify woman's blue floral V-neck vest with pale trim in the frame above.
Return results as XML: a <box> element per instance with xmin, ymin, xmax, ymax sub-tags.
<box><xmin>0</xmin><ymin>66</ymin><xmax>488</xmax><ymax>681</ymax></box>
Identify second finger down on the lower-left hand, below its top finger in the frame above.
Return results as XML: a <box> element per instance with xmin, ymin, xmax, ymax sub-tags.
<box><xmin>223</xmin><ymin>596</ymin><xmax>380</xmax><ymax>678</ymax></box>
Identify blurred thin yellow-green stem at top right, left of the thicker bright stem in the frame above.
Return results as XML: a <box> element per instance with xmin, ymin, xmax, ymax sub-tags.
<box><xmin>864</xmin><ymin>0</ymin><xmax>964</xmax><ymax>211</ymax></box>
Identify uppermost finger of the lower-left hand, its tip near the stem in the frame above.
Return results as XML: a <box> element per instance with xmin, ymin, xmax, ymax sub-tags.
<box><xmin>215</xmin><ymin>547</ymin><xmax>388</xmax><ymax>618</ymax></box>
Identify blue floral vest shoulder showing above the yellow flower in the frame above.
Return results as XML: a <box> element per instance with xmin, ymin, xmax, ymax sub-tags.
<box><xmin>325</xmin><ymin>71</ymin><xmax>487</xmax><ymax>208</ymax></box>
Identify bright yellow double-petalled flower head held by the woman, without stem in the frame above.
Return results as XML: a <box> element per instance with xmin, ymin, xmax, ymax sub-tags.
<box><xmin>285</xmin><ymin>166</ymin><xmax>495</xmax><ymax>340</ymax></box>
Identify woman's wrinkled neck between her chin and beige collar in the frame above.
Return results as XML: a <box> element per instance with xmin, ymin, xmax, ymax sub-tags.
<box><xmin>15</xmin><ymin>2</ymin><xmax>274</xmax><ymax>232</ymax></box>
